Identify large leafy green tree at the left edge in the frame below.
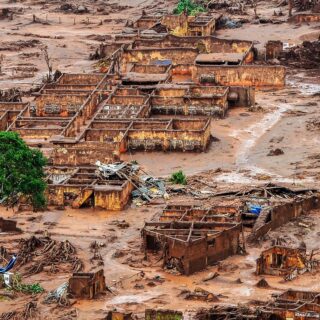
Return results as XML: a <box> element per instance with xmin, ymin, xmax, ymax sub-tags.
<box><xmin>0</xmin><ymin>132</ymin><xmax>47</xmax><ymax>210</ymax></box>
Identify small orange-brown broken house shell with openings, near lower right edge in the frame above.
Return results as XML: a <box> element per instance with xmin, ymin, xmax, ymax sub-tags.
<box><xmin>256</xmin><ymin>245</ymin><xmax>319</xmax><ymax>280</ymax></box>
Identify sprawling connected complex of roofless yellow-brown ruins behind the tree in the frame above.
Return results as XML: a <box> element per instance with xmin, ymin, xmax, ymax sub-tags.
<box><xmin>0</xmin><ymin>13</ymin><xmax>285</xmax><ymax>210</ymax></box>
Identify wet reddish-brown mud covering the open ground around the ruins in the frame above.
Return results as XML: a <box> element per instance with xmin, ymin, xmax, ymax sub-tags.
<box><xmin>0</xmin><ymin>0</ymin><xmax>320</xmax><ymax>319</ymax></box>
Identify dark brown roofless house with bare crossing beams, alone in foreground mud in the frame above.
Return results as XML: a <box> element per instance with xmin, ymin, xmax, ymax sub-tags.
<box><xmin>142</xmin><ymin>221</ymin><xmax>242</xmax><ymax>275</ymax></box>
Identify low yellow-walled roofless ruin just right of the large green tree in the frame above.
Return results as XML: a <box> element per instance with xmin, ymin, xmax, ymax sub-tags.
<box><xmin>47</xmin><ymin>166</ymin><xmax>134</xmax><ymax>210</ymax></box>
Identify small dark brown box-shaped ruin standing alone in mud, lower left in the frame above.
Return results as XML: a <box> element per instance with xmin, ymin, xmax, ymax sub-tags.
<box><xmin>69</xmin><ymin>269</ymin><xmax>106</xmax><ymax>299</ymax></box>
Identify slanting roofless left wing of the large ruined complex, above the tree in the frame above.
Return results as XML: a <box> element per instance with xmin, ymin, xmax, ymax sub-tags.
<box><xmin>7</xmin><ymin>74</ymin><xmax>108</xmax><ymax>144</ymax></box>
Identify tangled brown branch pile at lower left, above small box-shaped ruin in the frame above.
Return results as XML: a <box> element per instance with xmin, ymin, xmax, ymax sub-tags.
<box><xmin>18</xmin><ymin>236</ymin><xmax>83</xmax><ymax>274</ymax></box>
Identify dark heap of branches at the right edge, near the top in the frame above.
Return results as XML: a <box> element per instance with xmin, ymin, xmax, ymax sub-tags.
<box><xmin>281</xmin><ymin>40</ymin><xmax>320</xmax><ymax>69</ymax></box>
